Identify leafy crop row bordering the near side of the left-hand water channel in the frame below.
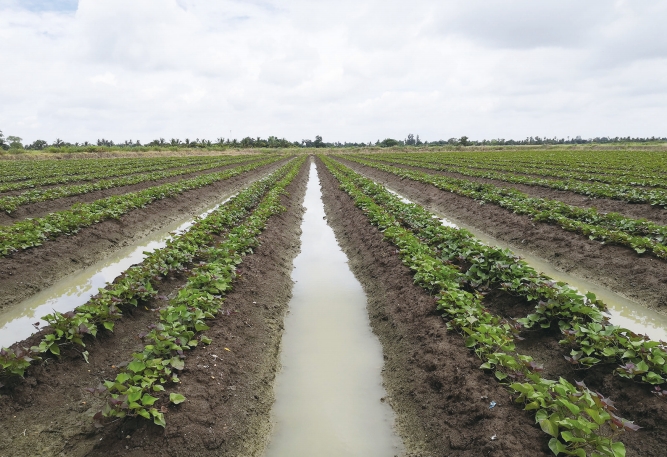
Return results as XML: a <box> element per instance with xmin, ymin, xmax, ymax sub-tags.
<box><xmin>0</xmin><ymin>159</ymin><xmax>298</xmax><ymax>376</ymax></box>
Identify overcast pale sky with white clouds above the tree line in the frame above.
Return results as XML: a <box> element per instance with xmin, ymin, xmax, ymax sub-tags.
<box><xmin>0</xmin><ymin>0</ymin><xmax>667</xmax><ymax>142</ymax></box>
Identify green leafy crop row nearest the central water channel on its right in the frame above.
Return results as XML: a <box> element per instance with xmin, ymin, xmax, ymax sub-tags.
<box><xmin>323</xmin><ymin>158</ymin><xmax>638</xmax><ymax>456</ymax></box>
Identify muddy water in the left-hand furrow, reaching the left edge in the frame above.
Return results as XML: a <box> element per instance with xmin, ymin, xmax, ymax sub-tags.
<box><xmin>0</xmin><ymin>195</ymin><xmax>232</xmax><ymax>347</ymax></box>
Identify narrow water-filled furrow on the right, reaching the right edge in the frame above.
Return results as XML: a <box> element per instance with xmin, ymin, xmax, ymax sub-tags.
<box><xmin>378</xmin><ymin>186</ymin><xmax>667</xmax><ymax>341</ymax></box>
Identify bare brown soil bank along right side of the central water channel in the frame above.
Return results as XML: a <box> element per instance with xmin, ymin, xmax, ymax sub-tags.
<box><xmin>318</xmin><ymin>157</ymin><xmax>550</xmax><ymax>457</ymax></box>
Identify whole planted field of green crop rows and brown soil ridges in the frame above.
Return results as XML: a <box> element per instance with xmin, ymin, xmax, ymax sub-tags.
<box><xmin>0</xmin><ymin>148</ymin><xmax>667</xmax><ymax>457</ymax></box>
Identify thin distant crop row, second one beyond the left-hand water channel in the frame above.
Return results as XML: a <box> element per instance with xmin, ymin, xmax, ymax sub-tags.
<box><xmin>0</xmin><ymin>156</ymin><xmax>260</xmax><ymax>213</ymax></box>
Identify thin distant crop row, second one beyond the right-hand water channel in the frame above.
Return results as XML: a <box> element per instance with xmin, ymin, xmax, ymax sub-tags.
<box><xmin>372</xmin><ymin>156</ymin><xmax>667</xmax><ymax>206</ymax></box>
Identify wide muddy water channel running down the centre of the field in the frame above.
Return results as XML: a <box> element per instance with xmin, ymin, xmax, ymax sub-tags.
<box><xmin>265</xmin><ymin>163</ymin><xmax>402</xmax><ymax>457</ymax></box>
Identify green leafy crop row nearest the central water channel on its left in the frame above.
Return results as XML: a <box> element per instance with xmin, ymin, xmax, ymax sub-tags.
<box><xmin>90</xmin><ymin>157</ymin><xmax>305</xmax><ymax>426</ymax></box>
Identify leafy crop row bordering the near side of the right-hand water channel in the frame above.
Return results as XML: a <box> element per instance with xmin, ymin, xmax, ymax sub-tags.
<box><xmin>332</xmin><ymin>158</ymin><xmax>667</xmax><ymax>384</ymax></box>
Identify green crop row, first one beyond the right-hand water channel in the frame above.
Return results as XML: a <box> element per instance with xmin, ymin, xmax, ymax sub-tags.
<box><xmin>346</xmin><ymin>156</ymin><xmax>667</xmax><ymax>259</ymax></box>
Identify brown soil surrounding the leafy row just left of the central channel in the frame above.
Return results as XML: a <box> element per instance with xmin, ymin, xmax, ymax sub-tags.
<box><xmin>0</xmin><ymin>158</ymin><xmax>308</xmax><ymax>457</ymax></box>
